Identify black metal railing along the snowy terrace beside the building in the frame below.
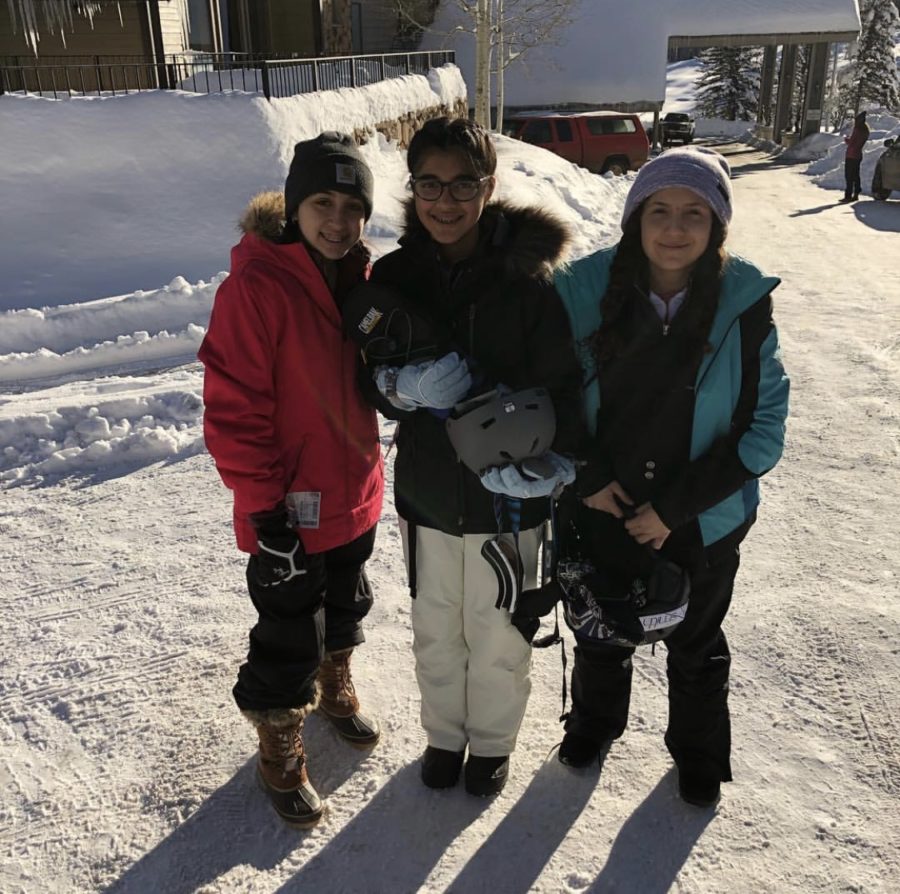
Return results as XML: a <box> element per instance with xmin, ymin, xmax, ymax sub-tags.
<box><xmin>0</xmin><ymin>51</ymin><xmax>455</xmax><ymax>99</ymax></box>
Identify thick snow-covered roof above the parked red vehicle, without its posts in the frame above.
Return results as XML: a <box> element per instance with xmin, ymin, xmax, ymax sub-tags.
<box><xmin>423</xmin><ymin>0</ymin><xmax>859</xmax><ymax>108</ymax></box>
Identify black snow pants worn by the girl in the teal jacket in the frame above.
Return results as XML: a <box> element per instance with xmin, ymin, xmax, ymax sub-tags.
<box><xmin>566</xmin><ymin>549</ymin><xmax>740</xmax><ymax>782</ymax></box>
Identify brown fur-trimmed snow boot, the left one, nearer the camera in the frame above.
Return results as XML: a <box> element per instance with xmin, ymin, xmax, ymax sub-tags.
<box><xmin>243</xmin><ymin>705</ymin><xmax>324</xmax><ymax>829</ymax></box>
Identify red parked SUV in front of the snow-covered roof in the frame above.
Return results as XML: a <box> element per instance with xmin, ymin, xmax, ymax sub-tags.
<box><xmin>503</xmin><ymin>111</ymin><xmax>650</xmax><ymax>174</ymax></box>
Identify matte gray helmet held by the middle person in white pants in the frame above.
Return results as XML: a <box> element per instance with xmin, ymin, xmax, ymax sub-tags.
<box><xmin>446</xmin><ymin>388</ymin><xmax>556</xmax><ymax>475</ymax></box>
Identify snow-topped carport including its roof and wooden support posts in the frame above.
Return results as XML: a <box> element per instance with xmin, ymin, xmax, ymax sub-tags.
<box><xmin>423</xmin><ymin>0</ymin><xmax>860</xmax><ymax>141</ymax></box>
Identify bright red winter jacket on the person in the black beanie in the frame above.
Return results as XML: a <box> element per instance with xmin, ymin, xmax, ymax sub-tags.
<box><xmin>199</xmin><ymin>193</ymin><xmax>384</xmax><ymax>553</ymax></box>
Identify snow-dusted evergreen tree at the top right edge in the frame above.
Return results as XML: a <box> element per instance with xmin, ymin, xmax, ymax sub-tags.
<box><xmin>839</xmin><ymin>0</ymin><xmax>900</xmax><ymax>114</ymax></box>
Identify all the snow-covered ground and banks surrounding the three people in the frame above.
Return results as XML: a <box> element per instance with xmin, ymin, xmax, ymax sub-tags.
<box><xmin>0</xmin><ymin>65</ymin><xmax>900</xmax><ymax>894</ymax></box>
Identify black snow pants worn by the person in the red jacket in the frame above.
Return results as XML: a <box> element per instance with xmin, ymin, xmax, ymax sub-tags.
<box><xmin>233</xmin><ymin>527</ymin><xmax>375</xmax><ymax>711</ymax></box>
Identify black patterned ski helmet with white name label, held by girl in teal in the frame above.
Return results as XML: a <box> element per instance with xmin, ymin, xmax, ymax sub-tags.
<box><xmin>557</xmin><ymin>557</ymin><xmax>691</xmax><ymax>647</ymax></box>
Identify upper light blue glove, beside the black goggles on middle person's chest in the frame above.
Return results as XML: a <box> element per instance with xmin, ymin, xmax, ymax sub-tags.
<box><xmin>375</xmin><ymin>351</ymin><xmax>472</xmax><ymax>410</ymax></box>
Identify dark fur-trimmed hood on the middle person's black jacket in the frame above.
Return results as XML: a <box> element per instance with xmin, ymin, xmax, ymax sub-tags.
<box><xmin>400</xmin><ymin>199</ymin><xmax>572</xmax><ymax>279</ymax></box>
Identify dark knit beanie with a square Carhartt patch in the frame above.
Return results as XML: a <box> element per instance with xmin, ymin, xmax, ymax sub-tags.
<box><xmin>284</xmin><ymin>130</ymin><xmax>375</xmax><ymax>220</ymax></box>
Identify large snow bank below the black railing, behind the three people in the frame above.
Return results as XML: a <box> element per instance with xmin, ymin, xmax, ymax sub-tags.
<box><xmin>0</xmin><ymin>86</ymin><xmax>633</xmax><ymax>392</ymax></box>
